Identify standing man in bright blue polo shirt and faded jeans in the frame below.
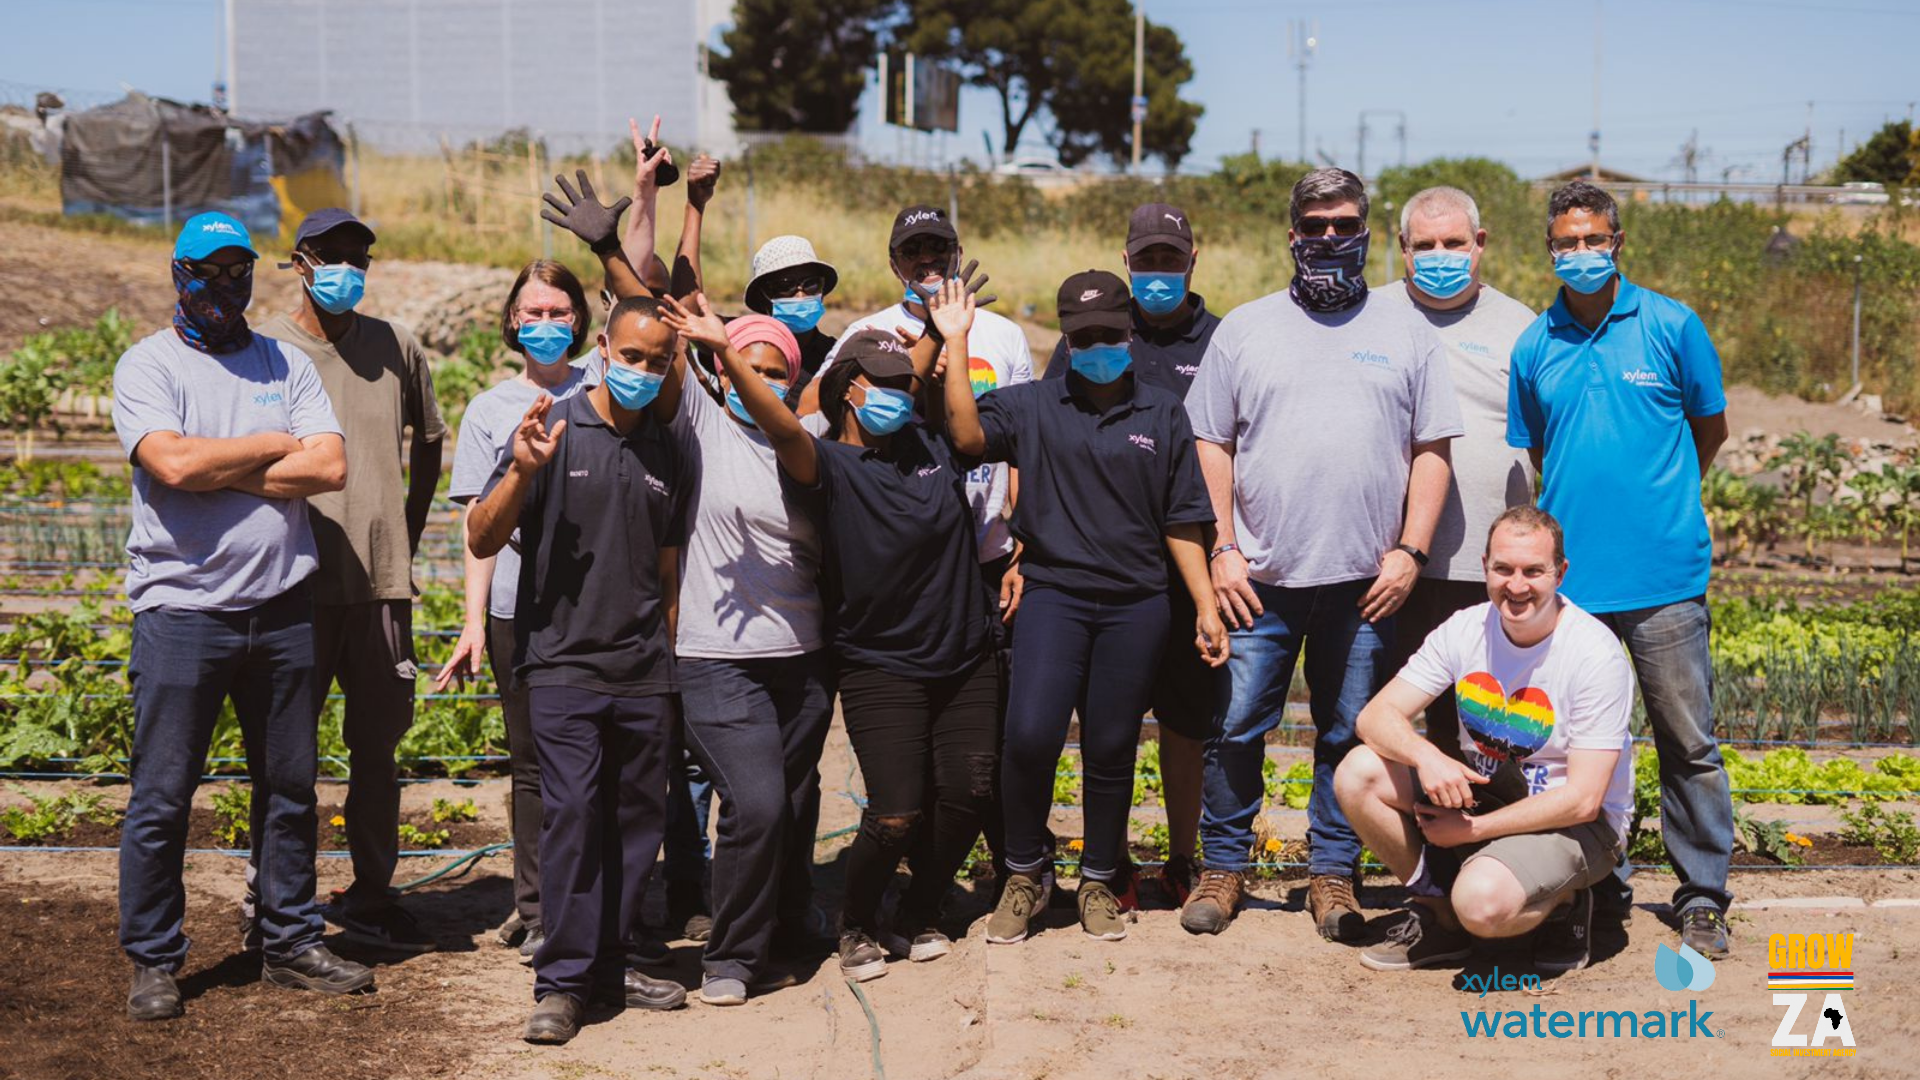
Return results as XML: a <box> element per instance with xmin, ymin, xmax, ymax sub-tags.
<box><xmin>1507</xmin><ymin>181</ymin><xmax>1734</xmax><ymax>957</ymax></box>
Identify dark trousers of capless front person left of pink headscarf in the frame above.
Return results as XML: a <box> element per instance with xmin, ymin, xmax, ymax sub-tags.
<box><xmin>528</xmin><ymin>686</ymin><xmax>674</xmax><ymax>1001</ymax></box>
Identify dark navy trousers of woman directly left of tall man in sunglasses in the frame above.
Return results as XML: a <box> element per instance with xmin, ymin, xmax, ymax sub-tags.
<box><xmin>1000</xmin><ymin>586</ymin><xmax>1167</xmax><ymax>880</ymax></box>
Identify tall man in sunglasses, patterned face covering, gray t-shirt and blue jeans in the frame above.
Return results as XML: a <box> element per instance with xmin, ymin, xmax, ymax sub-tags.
<box><xmin>1181</xmin><ymin>169</ymin><xmax>1463</xmax><ymax>942</ymax></box>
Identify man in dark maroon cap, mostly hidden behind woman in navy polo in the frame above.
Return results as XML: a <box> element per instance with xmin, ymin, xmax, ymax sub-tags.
<box><xmin>1044</xmin><ymin>202</ymin><xmax>1219</xmax><ymax>907</ymax></box>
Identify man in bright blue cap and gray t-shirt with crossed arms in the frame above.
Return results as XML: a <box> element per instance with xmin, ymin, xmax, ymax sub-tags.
<box><xmin>113</xmin><ymin>213</ymin><xmax>372</xmax><ymax>1020</ymax></box>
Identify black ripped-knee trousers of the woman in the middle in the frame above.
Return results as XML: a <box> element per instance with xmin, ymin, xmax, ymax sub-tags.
<box><xmin>839</xmin><ymin>651</ymin><xmax>1000</xmax><ymax>934</ymax></box>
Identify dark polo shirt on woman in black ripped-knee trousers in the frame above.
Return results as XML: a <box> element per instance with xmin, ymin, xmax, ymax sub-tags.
<box><xmin>780</xmin><ymin>417</ymin><xmax>993</xmax><ymax>678</ymax></box>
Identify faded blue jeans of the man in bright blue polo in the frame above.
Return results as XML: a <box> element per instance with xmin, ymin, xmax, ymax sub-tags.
<box><xmin>1596</xmin><ymin>596</ymin><xmax>1734</xmax><ymax>915</ymax></box>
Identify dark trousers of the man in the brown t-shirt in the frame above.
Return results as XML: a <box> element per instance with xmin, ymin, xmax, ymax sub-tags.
<box><xmin>313</xmin><ymin>600</ymin><xmax>419</xmax><ymax>909</ymax></box>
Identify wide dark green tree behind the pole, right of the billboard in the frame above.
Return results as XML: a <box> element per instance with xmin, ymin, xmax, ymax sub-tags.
<box><xmin>900</xmin><ymin>0</ymin><xmax>1200</xmax><ymax>167</ymax></box>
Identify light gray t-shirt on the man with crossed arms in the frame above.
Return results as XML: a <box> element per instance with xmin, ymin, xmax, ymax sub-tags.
<box><xmin>113</xmin><ymin>327</ymin><xmax>340</xmax><ymax>611</ymax></box>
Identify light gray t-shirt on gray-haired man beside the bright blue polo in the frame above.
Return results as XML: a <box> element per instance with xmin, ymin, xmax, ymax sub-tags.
<box><xmin>1380</xmin><ymin>281</ymin><xmax>1534</xmax><ymax>580</ymax></box>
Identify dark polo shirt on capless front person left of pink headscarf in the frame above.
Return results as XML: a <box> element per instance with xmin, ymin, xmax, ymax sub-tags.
<box><xmin>482</xmin><ymin>394</ymin><xmax>687</xmax><ymax>698</ymax></box>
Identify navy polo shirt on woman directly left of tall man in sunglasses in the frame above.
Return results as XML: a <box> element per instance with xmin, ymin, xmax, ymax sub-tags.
<box><xmin>979</xmin><ymin>373</ymin><xmax>1213</xmax><ymax>600</ymax></box>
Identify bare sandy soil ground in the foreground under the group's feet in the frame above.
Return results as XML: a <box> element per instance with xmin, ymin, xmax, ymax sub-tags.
<box><xmin>0</xmin><ymin>726</ymin><xmax>1920</xmax><ymax>1080</ymax></box>
